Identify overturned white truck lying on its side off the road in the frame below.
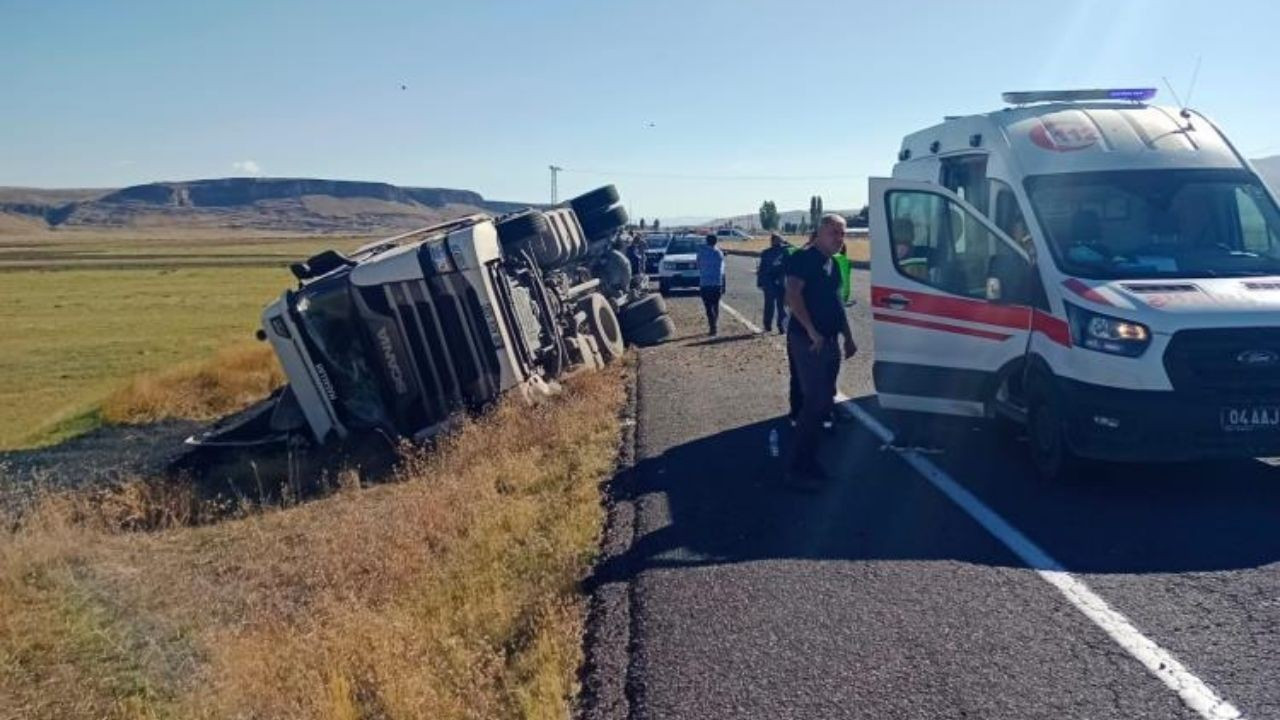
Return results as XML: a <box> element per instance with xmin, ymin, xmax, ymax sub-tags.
<box><xmin>188</xmin><ymin>186</ymin><xmax>673</xmax><ymax>448</ymax></box>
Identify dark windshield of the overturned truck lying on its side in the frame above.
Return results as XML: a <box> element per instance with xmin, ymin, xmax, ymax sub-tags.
<box><xmin>293</xmin><ymin>275</ymin><xmax>390</xmax><ymax>428</ymax></box>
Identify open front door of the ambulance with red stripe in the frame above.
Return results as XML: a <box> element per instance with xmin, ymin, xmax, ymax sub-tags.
<box><xmin>869</xmin><ymin>178</ymin><xmax>1033</xmax><ymax>416</ymax></box>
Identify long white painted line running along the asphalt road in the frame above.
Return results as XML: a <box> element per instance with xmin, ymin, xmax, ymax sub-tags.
<box><xmin>721</xmin><ymin>302</ymin><xmax>1243</xmax><ymax>720</ymax></box>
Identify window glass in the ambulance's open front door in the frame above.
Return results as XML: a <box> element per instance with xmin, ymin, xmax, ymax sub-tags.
<box><xmin>887</xmin><ymin>191</ymin><xmax>1025</xmax><ymax>300</ymax></box>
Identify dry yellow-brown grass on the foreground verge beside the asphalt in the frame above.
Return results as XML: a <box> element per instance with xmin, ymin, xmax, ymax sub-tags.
<box><xmin>0</xmin><ymin>369</ymin><xmax>625</xmax><ymax>720</ymax></box>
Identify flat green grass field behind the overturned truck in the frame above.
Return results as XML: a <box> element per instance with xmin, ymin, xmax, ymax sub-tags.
<box><xmin>0</xmin><ymin>232</ymin><xmax>362</xmax><ymax>450</ymax></box>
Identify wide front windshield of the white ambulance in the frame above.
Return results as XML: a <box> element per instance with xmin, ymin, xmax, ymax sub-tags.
<box><xmin>1027</xmin><ymin>170</ymin><xmax>1280</xmax><ymax>279</ymax></box>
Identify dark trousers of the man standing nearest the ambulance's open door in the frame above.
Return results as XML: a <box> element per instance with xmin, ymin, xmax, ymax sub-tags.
<box><xmin>787</xmin><ymin>332</ymin><xmax>840</xmax><ymax>473</ymax></box>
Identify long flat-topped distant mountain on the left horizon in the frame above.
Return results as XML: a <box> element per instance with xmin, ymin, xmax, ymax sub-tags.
<box><xmin>0</xmin><ymin>178</ymin><xmax>529</xmax><ymax>233</ymax></box>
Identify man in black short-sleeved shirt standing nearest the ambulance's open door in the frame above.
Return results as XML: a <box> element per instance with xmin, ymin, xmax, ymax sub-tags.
<box><xmin>786</xmin><ymin>210</ymin><xmax>858</xmax><ymax>488</ymax></box>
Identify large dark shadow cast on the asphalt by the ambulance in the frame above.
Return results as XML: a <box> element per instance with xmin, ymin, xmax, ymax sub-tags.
<box><xmin>593</xmin><ymin>397</ymin><xmax>1280</xmax><ymax>582</ymax></box>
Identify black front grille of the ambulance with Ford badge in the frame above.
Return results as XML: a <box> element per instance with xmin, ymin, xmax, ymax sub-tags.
<box><xmin>1165</xmin><ymin>328</ymin><xmax>1280</xmax><ymax>396</ymax></box>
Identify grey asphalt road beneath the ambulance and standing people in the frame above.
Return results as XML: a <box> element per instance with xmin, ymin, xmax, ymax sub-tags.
<box><xmin>583</xmin><ymin>258</ymin><xmax>1280</xmax><ymax>719</ymax></box>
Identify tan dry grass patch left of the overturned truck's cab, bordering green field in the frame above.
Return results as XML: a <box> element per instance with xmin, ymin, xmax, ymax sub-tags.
<box><xmin>101</xmin><ymin>343</ymin><xmax>285</xmax><ymax>424</ymax></box>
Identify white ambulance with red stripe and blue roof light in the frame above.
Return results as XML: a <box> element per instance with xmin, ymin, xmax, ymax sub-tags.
<box><xmin>869</xmin><ymin>88</ymin><xmax>1280</xmax><ymax>477</ymax></box>
